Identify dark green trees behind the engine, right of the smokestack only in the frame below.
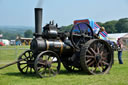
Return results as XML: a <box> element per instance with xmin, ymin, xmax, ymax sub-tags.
<box><xmin>60</xmin><ymin>18</ymin><xmax>128</xmax><ymax>33</ymax></box>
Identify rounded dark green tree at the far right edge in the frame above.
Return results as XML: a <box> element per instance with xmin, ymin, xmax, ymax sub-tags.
<box><xmin>115</xmin><ymin>18</ymin><xmax>128</xmax><ymax>33</ymax></box>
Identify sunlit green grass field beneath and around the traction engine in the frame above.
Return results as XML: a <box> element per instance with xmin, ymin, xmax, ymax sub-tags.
<box><xmin>0</xmin><ymin>47</ymin><xmax>128</xmax><ymax>85</ymax></box>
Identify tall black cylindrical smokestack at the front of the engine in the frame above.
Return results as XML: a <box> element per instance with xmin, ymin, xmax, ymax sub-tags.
<box><xmin>35</xmin><ymin>8</ymin><xmax>42</xmax><ymax>37</ymax></box>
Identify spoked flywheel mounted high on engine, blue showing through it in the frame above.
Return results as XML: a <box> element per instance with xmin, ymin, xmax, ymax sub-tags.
<box><xmin>70</xmin><ymin>22</ymin><xmax>93</xmax><ymax>49</ymax></box>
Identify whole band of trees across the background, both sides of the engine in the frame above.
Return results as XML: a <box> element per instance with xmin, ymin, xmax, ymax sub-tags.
<box><xmin>0</xmin><ymin>18</ymin><xmax>128</xmax><ymax>40</ymax></box>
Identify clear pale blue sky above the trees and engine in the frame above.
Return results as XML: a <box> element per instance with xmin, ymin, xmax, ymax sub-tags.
<box><xmin>0</xmin><ymin>0</ymin><xmax>128</xmax><ymax>27</ymax></box>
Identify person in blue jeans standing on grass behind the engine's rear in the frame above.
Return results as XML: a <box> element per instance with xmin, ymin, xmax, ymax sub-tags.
<box><xmin>117</xmin><ymin>38</ymin><xmax>123</xmax><ymax>64</ymax></box>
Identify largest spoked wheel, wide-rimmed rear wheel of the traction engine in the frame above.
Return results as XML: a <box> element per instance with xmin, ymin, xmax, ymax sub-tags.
<box><xmin>80</xmin><ymin>39</ymin><xmax>113</xmax><ymax>74</ymax></box>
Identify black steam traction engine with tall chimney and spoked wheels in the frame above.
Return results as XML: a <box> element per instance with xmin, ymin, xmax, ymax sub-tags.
<box><xmin>0</xmin><ymin>8</ymin><xmax>113</xmax><ymax>77</ymax></box>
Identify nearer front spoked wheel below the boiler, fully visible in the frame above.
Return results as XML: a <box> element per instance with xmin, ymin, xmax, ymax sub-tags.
<box><xmin>34</xmin><ymin>51</ymin><xmax>60</xmax><ymax>78</ymax></box>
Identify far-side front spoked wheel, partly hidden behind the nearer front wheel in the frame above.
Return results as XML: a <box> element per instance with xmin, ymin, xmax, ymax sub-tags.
<box><xmin>17</xmin><ymin>50</ymin><xmax>35</xmax><ymax>74</ymax></box>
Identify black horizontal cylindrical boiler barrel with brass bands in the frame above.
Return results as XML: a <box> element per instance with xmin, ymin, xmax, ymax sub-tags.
<box><xmin>31</xmin><ymin>39</ymin><xmax>73</xmax><ymax>54</ymax></box>
